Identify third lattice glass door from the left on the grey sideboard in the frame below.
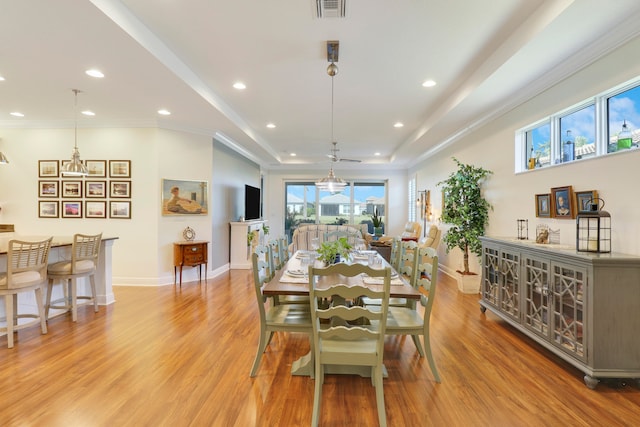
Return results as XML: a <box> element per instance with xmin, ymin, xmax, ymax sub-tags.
<box><xmin>522</xmin><ymin>257</ymin><xmax>551</xmax><ymax>338</ymax></box>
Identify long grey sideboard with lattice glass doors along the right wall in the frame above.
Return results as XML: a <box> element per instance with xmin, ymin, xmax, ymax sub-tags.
<box><xmin>480</xmin><ymin>237</ymin><xmax>640</xmax><ymax>388</ymax></box>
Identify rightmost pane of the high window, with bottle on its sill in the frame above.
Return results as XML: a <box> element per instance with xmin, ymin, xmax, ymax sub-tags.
<box><xmin>607</xmin><ymin>86</ymin><xmax>640</xmax><ymax>153</ymax></box>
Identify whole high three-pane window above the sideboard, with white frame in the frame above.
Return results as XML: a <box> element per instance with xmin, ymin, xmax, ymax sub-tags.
<box><xmin>515</xmin><ymin>77</ymin><xmax>640</xmax><ymax>172</ymax></box>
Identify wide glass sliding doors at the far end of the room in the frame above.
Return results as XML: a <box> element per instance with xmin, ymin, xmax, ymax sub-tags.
<box><xmin>284</xmin><ymin>182</ymin><xmax>386</xmax><ymax>237</ymax></box>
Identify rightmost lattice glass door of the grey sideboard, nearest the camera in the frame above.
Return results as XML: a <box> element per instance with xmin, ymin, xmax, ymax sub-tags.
<box><xmin>551</xmin><ymin>264</ymin><xmax>587</xmax><ymax>360</ymax></box>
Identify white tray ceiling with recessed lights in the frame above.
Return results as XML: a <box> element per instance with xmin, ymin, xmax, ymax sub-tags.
<box><xmin>0</xmin><ymin>0</ymin><xmax>640</xmax><ymax>170</ymax></box>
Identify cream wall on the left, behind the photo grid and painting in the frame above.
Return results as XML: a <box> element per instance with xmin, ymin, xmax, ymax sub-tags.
<box><xmin>0</xmin><ymin>129</ymin><xmax>213</xmax><ymax>285</ymax></box>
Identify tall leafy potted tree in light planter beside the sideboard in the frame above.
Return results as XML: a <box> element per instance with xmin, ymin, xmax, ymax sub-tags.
<box><xmin>438</xmin><ymin>157</ymin><xmax>493</xmax><ymax>293</ymax></box>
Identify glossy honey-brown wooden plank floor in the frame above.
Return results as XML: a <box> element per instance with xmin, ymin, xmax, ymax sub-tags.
<box><xmin>0</xmin><ymin>270</ymin><xmax>640</xmax><ymax>427</ymax></box>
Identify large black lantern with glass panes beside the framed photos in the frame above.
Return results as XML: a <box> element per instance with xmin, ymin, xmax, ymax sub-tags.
<box><xmin>576</xmin><ymin>198</ymin><xmax>611</xmax><ymax>253</ymax></box>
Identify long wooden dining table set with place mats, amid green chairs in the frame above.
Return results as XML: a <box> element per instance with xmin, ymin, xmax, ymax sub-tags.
<box><xmin>262</xmin><ymin>250</ymin><xmax>422</xmax><ymax>377</ymax></box>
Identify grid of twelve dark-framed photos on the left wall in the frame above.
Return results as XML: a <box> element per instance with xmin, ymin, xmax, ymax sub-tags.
<box><xmin>38</xmin><ymin>160</ymin><xmax>131</xmax><ymax>219</ymax></box>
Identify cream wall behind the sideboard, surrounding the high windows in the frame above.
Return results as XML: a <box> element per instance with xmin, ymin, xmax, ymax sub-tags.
<box><xmin>410</xmin><ymin>38</ymin><xmax>640</xmax><ymax>280</ymax></box>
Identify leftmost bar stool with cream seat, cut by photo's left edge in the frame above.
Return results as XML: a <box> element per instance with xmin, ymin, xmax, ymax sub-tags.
<box><xmin>0</xmin><ymin>237</ymin><xmax>53</xmax><ymax>348</ymax></box>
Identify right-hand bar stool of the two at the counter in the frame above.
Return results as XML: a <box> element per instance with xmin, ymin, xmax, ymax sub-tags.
<box><xmin>46</xmin><ymin>233</ymin><xmax>102</xmax><ymax>322</ymax></box>
